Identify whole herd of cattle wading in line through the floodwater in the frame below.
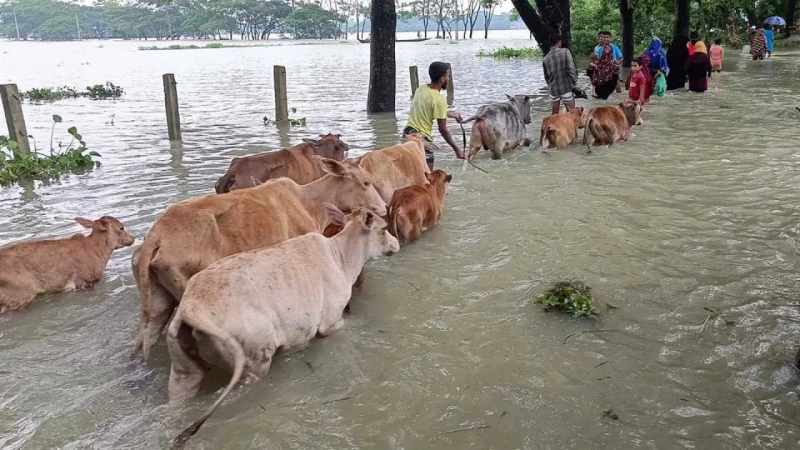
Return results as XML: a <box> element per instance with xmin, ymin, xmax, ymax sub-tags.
<box><xmin>0</xmin><ymin>96</ymin><xmax>641</xmax><ymax>447</ymax></box>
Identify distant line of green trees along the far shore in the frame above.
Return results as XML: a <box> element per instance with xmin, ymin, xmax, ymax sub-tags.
<box><xmin>0</xmin><ymin>0</ymin><xmax>525</xmax><ymax>41</ymax></box>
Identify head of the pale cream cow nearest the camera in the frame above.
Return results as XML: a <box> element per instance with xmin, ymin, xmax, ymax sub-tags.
<box><xmin>324</xmin><ymin>203</ymin><xmax>400</xmax><ymax>259</ymax></box>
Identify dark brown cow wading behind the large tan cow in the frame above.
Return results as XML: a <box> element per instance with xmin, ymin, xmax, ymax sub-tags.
<box><xmin>214</xmin><ymin>134</ymin><xmax>350</xmax><ymax>194</ymax></box>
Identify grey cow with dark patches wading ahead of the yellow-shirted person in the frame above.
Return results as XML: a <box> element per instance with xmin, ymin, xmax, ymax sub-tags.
<box><xmin>462</xmin><ymin>95</ymin><xmax>531</xmax><ymax>160</ymax></box>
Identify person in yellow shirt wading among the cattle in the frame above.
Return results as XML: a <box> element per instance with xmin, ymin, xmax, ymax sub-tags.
<box><xmin>403</xmin><ymin>61</ymin><xmax>464</xmax><ymax>170</ymax></box>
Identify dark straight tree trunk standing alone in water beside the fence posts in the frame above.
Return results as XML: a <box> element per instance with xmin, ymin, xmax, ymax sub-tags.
<box><xmin>367</xmin><ymin>0</ymin><xmax>397</xmax><ymax>113</ymax></box>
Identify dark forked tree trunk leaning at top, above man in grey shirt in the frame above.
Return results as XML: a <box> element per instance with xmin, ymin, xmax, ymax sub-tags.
<box><xmin>511</xmin><ymin>0</ymin><xmax>572</xmax><ymax>54</ymax></box>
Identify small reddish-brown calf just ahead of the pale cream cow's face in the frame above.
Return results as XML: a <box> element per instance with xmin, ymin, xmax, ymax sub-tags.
<box><xmin>388</xmin><ymin>169</ymin><xmax>453</xmax><ymax>244</ymax></box>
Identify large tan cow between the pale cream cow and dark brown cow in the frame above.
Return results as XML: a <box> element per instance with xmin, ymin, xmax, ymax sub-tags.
<box><xmin>132</xmin><ymin>157</ymin><xmax>386</xmax><ymax>357</ymax></box>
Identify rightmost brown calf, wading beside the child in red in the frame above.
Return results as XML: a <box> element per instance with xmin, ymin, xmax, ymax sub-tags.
<box><xmin>583</xmin><ymin>102</ymin><xmax>643</xmax><ymax>152</ymax></box>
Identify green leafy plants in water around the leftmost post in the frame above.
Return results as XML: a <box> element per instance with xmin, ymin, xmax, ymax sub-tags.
<box><xmin>0</xmin><ymin>119</ymin><xmax>100</xmax><ymax>186</ymax></box>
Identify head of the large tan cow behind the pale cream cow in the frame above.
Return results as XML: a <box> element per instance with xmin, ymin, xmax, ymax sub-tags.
<box><xmin>314</xmin><ymin>156</ymin><xmax>386</xmax><ymax>216</ymax></box>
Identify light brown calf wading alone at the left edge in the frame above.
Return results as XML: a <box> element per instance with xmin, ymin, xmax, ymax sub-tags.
<box><xmin>0</xmin><ymin>216</ymin><xmax>135</xmax><ymax>314</ymax></box>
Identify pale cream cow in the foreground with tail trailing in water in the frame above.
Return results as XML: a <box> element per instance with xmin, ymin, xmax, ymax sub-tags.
<box><xmin>167</xmin><ymin>205</ymin><xmax>400</xmax><ymax>448</ymax></box>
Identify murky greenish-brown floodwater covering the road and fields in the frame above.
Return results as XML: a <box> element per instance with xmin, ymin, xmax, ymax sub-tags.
<box><xmin>0</xmin><ymin>36</ymin><xmax>800</xmax><ymax>449</ymax></box>
